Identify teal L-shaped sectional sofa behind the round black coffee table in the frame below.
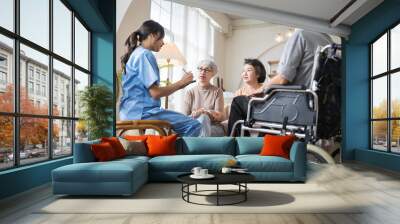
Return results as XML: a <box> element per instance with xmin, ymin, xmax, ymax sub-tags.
<box><xmin>52</xmin><ymin>137</ymin><xmax>306</xmax><ymax>195</ymax></box>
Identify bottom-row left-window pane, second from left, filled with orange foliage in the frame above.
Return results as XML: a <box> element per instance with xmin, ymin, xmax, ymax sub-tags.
<box><xmin>19</xmin><ymin>117</ymin><xmax>49</xmax><ymax>164</ymax></box>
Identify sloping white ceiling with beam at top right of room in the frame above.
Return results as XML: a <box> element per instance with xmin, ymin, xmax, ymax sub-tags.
<box><xmin>173</xmin><ymin>0</ymin><xmax>383</xmax><ymax>37</ymax></box>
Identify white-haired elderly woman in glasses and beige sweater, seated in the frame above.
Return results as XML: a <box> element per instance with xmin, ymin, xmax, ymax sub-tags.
<box><xmin>183</xmin><ymin>60</ymin><xmax>225</xmax><ymax>136</ymax></box>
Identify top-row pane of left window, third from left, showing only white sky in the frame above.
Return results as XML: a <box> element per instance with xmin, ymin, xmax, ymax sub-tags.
<box><xmin>53</xmin><ymin>0</ymin><xmax>72</xmax><ymax>60</ymax></box>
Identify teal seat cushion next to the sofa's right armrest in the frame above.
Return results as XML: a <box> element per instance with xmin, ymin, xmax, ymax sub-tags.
<box><xmin>236</xmin><ymin>155</ymin><xmax>293</xmax><ymax>172</ymax></box>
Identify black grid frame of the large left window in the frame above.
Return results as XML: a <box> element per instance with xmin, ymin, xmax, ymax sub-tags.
<box><xmin>0</xmin><ymin>0</ymin><xmax>93</xmax><ymax>172</ymax></box>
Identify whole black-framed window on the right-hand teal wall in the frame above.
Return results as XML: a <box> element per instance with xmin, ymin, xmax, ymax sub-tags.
<box><xmin>370</xmin><ymin>22</ymin><xmax>400</xmax><ymax>153</ymax></box>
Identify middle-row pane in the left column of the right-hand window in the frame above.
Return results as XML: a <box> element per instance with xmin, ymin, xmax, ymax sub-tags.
<box><xmin>372</xmin><ymin>76</ymin><xmax>388</xmax><ymax>118</ymax></box>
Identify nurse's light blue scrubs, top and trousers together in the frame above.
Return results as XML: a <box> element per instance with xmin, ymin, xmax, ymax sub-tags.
<box><xmin>119</xmin><ymin>46</ymin><xmax>201</xmax><ymax>136</ymax></box>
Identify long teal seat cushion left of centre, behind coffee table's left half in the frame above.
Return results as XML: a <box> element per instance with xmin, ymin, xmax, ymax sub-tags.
<box><xmin>149</xmin><ymin>154</ymin><xmax>235</xmax><ymax>172</ymax></box>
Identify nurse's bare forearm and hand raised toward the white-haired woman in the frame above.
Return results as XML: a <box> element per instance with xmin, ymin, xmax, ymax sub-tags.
<box><xmin>149</xmin><ymin>73</ymin><xmax>193</xmax><ymax>99</ymax></box>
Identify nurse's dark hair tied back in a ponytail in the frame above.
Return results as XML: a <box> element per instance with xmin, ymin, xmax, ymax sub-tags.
<box><xmin>121</xmin><ymin>20</ymin><xmax>165</xmax><ymax>71</ymax></box>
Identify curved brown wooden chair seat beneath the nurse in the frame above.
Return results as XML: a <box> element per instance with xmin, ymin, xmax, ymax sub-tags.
<box><xmin>116</xmin><ymin>120</ymin><xmax>172</xmax><ymax>136</ymax></box>
